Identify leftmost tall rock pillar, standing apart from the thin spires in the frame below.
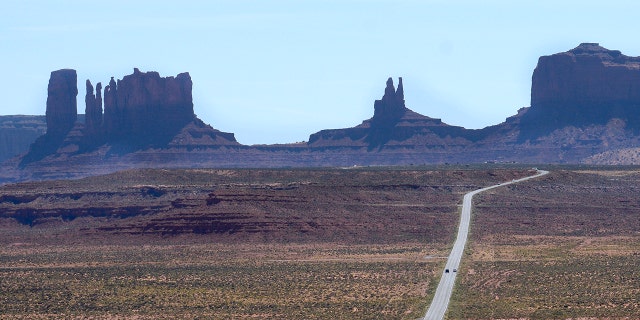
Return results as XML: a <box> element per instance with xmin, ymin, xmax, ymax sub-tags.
<box><xmin>46</xmin><ymin>69</ymin><xmax>78</xmax><ymax>136</ymax></box>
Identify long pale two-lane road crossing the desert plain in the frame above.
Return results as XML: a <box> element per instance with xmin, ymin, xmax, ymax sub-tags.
<box><xmin>423</xmin><ymin>170</ymin><xmax>549</xmax><ymax>320</ymax></box>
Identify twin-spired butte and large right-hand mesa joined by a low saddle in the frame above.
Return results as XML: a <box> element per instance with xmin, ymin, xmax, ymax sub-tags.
<box><xmin>308</xmin><ymin>43</ymin><xmax>640</xmax><ymax>163</ymax></box>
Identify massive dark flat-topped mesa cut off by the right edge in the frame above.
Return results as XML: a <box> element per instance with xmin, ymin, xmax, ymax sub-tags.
<box><xmin>520</xmin><ymin>43</ymin><xmax>640</xmax><ymax>140</ymax></box>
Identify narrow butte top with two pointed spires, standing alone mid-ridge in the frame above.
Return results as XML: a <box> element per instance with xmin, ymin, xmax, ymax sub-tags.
<box><xmin>371</xmin><ymin>77</ymin><xmax>408</xmax><ymax>126</ymax></box>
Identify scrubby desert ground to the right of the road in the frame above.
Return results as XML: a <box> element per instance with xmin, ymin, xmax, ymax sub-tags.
<box><xmin>448</xmin><ymin>169</ymin><xmax>640</xmax><ymax>319</ymax></box>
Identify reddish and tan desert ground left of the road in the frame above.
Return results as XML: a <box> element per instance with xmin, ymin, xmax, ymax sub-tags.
<box><xmin>0</xmin><ymin>168</ymin><xmax>531</xmax><ymax>319</ymax></box>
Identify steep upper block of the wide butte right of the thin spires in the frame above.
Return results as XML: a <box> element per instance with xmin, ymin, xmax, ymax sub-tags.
<box><xmin>104</xmin><ymin>68</ymin><xmax>195</xmax><ymax>144</ymax></box>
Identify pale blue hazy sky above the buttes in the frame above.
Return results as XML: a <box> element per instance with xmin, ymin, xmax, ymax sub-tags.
<box><xmin>0</xmin><ymin>0</ymin><xmax>640</xmax><ymax>145</ymax></box>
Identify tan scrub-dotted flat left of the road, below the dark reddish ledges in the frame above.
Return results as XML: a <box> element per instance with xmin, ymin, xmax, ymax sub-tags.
<box><xmin>0</xmin><ymin>244</ymin><xmax>438</xmax><ymax>319</ymax></box>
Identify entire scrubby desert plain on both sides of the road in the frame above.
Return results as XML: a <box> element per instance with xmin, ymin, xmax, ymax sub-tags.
<box><xmin>0</xmin><ymin>165</ymin><xmax>640</xmax><ymax>319</ymax></box>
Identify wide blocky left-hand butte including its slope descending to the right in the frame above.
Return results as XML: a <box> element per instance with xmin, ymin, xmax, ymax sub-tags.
<box><xmin>96</xmin><ymin>68</ymin><xmax>238</xmax><ymax>152</ymax></box>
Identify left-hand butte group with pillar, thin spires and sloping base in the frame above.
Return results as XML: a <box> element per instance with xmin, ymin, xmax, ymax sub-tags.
<box><xmin>20</xmin><ymin>68</ymin><xmax>238</xmax><ymax>167</ymax></box>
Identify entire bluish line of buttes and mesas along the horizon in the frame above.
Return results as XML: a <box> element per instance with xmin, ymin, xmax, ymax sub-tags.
<box><xmin>0</xmin><ymin>43</ymin><xmax>640</xmax><ymax>181</ymax></box>
